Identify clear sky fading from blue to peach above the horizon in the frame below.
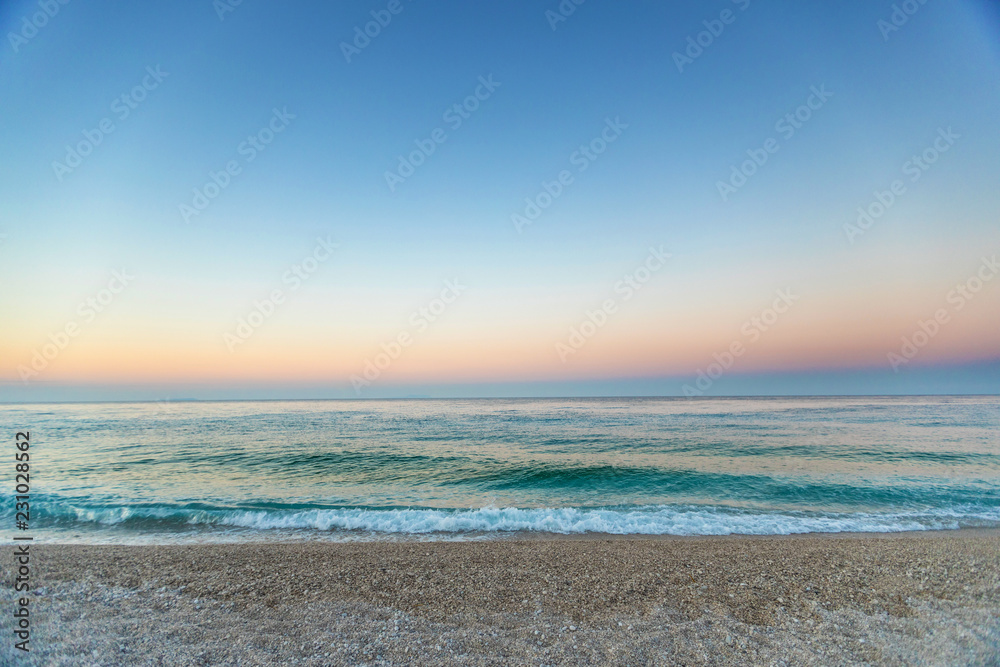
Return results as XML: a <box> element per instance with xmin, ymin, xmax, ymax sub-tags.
<box><xmin>0</xmin><ymin>0</ymin><xmax>1000</xmax><ymax>402</ymax></box>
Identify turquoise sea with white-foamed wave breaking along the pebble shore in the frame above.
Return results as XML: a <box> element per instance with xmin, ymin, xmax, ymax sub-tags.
<box><xmin>0</xmin><ymin>397</ymin><xmax>1000</xmax><ymax>543</ymax></box>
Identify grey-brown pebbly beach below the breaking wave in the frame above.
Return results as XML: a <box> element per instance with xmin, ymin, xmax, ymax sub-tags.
<box><xmin>0</xmin><ymin>531</ymin><xmax>1000</xmax><ymax>665</ymax></box>
